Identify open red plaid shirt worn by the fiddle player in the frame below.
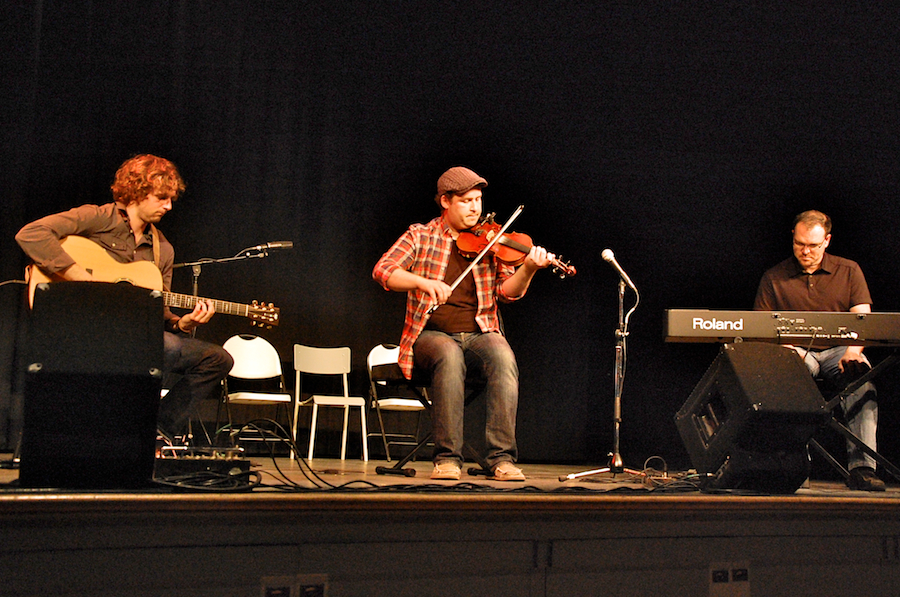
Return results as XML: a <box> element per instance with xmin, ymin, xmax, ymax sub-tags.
<box><xmin>372</xmin><ymin>218</ymin><xmax>524</xmax><ymax>379</ymax></box>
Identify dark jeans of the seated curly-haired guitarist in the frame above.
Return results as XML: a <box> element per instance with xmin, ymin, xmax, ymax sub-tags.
<box><xmin>156</xmin><ymin>332</ymin><xmax>234</xmax><ymax>435</ymax></box>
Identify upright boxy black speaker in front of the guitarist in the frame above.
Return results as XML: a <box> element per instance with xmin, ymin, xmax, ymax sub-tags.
<box><xmin>19</xmin><ymin>282</ymin><xmax>163</xmax><ymax>489</ymax></box>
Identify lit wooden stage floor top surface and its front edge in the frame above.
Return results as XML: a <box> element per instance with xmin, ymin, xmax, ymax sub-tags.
<box><xmin>0</xmin><ymin>454</ymin><xmax>900</xmax><ymax>506</ymax></box>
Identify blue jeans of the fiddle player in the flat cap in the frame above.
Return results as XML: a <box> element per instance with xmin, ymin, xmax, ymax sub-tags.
<box><xmin>413</xmin><ymin>330</ymin><xmax>519</xmax><ymax>467</ymax></box>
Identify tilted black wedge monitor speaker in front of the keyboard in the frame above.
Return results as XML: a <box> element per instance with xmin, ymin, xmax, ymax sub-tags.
<box><xmin>675</xmin><ymin>342</ymin><xmax>826</xmax><ymax>493</ymax></box>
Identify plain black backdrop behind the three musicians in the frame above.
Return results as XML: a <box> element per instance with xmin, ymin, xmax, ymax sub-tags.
<box><xmin>0</xmin><ymin>0</ymin><xmax>900</xmax><ymax>466</ymax></box>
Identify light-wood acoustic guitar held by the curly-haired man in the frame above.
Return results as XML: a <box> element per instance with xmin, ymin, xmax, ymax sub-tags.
<box><xmin>27</xmin><ymin>236</ymin><xmax>280</xmax><ymax>327</ymax></box>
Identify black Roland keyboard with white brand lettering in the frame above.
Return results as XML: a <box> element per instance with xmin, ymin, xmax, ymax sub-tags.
<box><xmin>665</xmin><ymin>309</ymin><xmax>900</xmax><ymax>346</ymax></box>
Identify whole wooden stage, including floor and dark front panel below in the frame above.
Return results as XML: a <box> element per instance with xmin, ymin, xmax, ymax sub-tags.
<box><xmin>0</xmin><ymin>456</ymin><xmax>900</xmax><ymax>597</ymax></box>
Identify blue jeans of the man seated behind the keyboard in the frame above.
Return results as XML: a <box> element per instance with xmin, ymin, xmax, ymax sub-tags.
<box><xmin>794</xmin><ymin>346</ymin><xmax>878</xmax><ymax>470</ymax></box>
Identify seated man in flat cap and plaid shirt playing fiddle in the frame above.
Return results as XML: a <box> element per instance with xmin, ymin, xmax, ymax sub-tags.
<box><xmin>372</xmin><ymin>166</ymin><xmax>553</xmax><ymax>481</ymax></box>
